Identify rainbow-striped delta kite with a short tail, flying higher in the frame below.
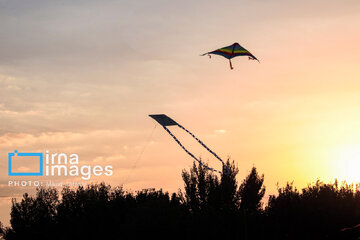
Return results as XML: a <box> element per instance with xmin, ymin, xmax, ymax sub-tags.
<box><xmin>201</xmin><ymin>43</ymin><xmax>260</xmax><ymax>69</ymax></box>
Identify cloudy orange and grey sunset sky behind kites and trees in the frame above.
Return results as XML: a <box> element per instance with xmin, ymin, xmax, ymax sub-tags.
<box><xmin>0</xmin><ymin>0</ymin><xmax>360</xmax><ymax>225</ymax></box>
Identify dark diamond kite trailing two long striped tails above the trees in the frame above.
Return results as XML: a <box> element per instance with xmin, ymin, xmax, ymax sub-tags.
<box><xmin>149</xmin><ymin>114</ymin><xmax>230</xmax><ymax>174</ymax></box>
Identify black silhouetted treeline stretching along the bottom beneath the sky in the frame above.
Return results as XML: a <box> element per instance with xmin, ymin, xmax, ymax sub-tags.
<box><xmin>1</xmin><ymin>161</ymin><xmax>360</xmax><ymax>240</ymax></box>
